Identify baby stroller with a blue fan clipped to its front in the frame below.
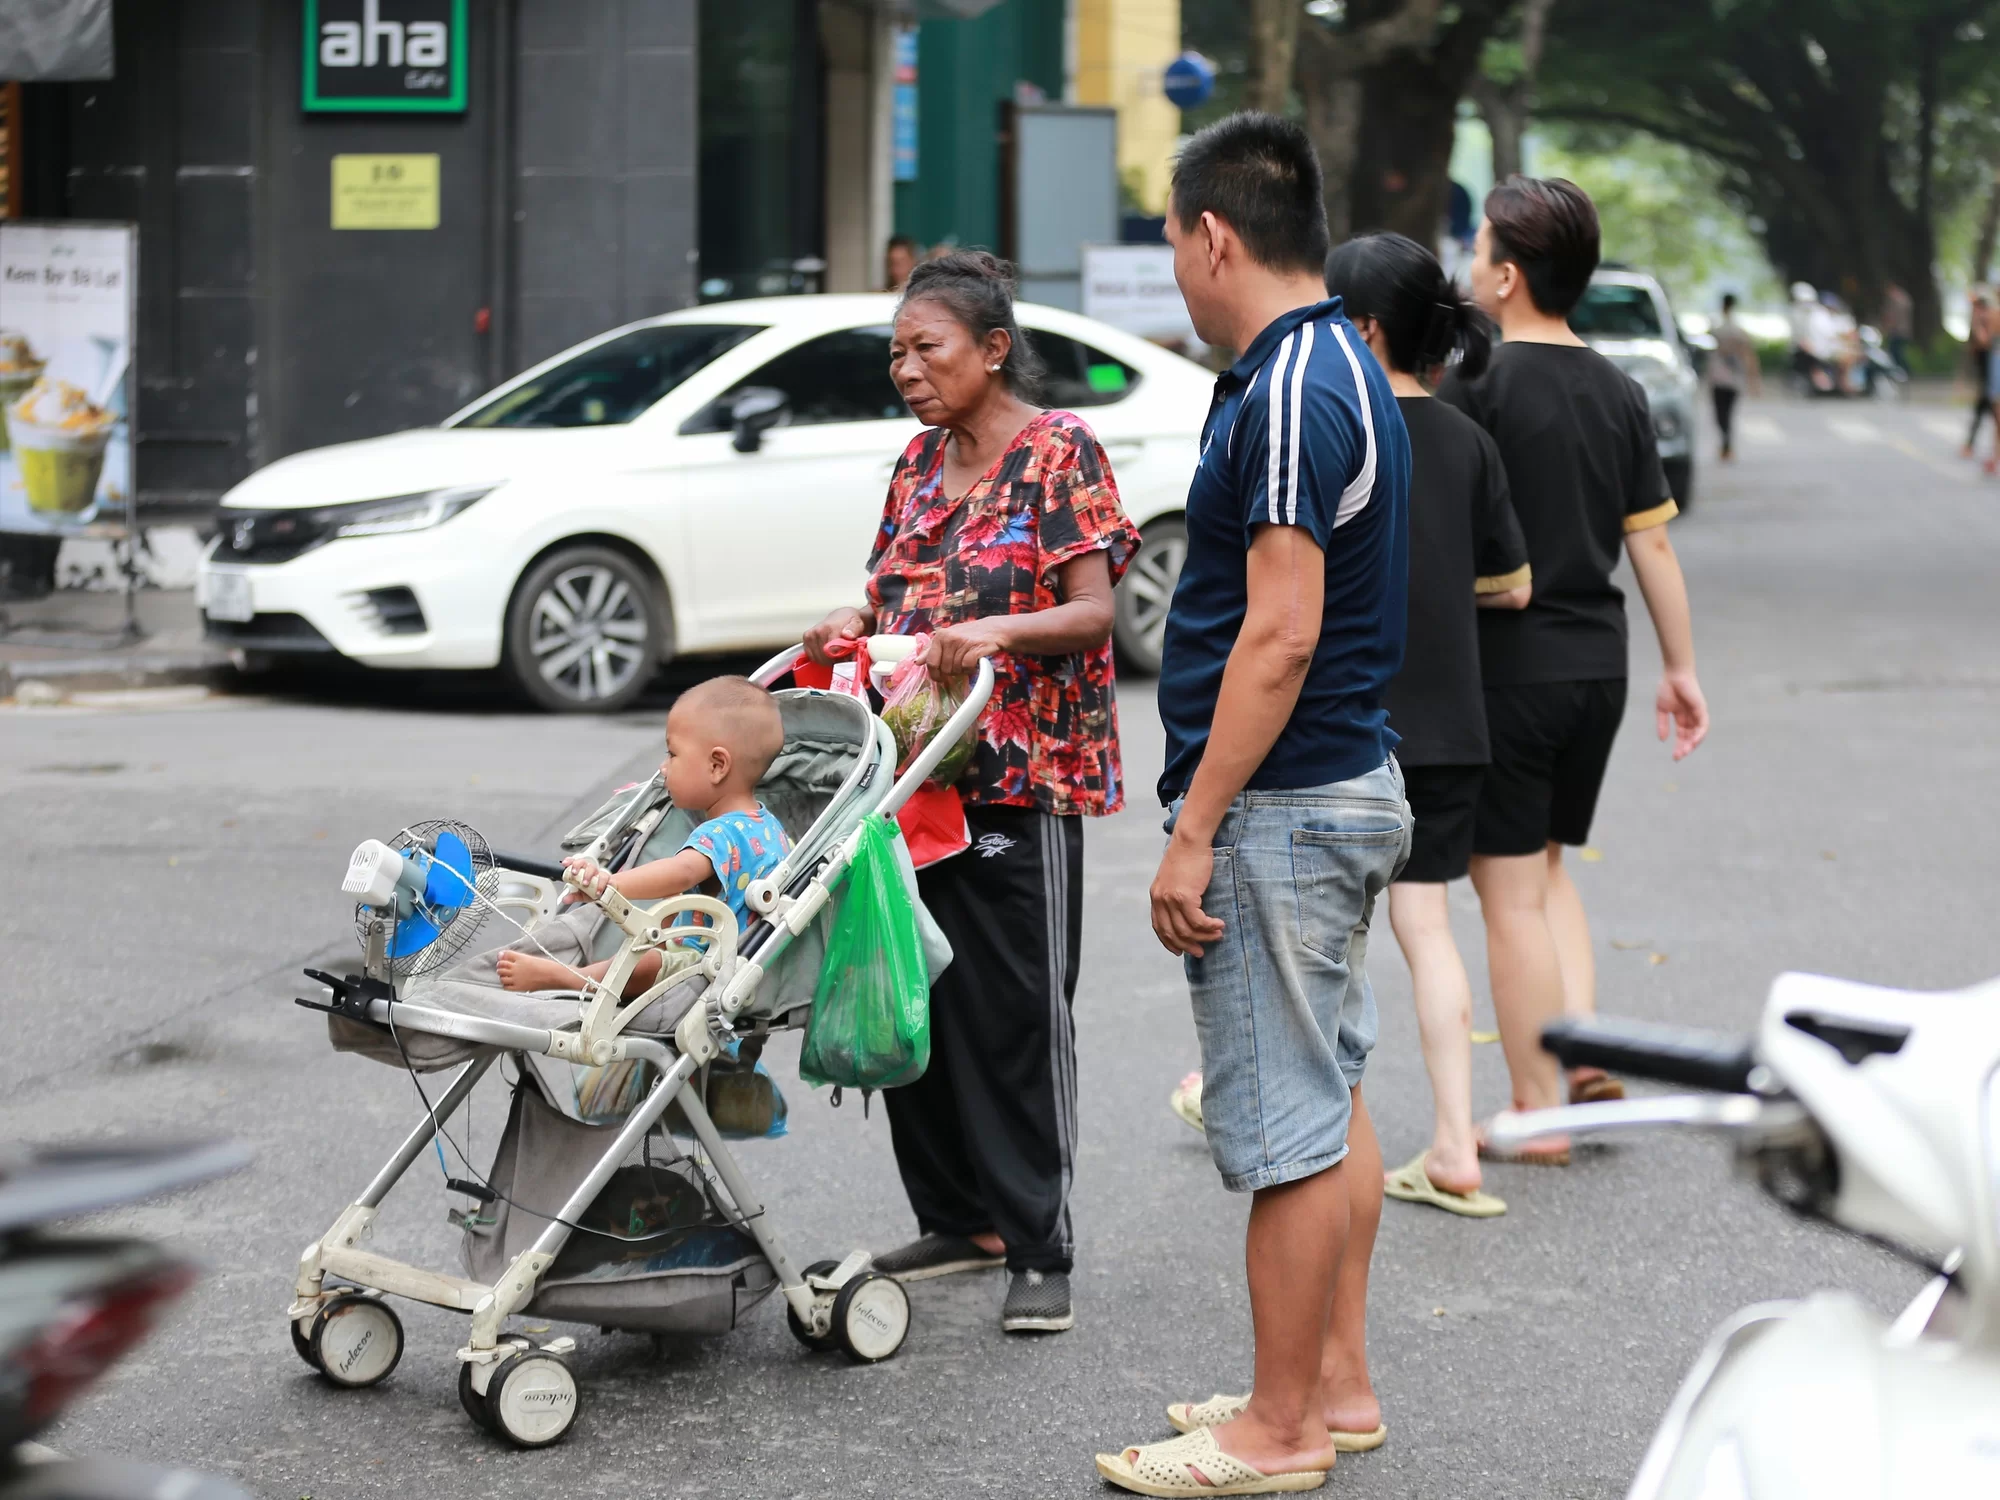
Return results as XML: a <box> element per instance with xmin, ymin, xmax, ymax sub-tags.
<box><xmin>286</xmin><ymin>650</ymin><xmax>992</xmax><ymax>1448</ymax></box>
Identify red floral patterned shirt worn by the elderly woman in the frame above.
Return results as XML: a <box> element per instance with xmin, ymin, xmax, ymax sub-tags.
<box><xmin>868</xmin><ymin>412</ymin><xmax>1138</xmax><ymax>814</ymax></box>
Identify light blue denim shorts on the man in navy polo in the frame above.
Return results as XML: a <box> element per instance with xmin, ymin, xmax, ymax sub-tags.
<box><xmin>1168</xmin><ymin>758</ymin><xmax>1410</xmax><ymax>1192</ymax></box>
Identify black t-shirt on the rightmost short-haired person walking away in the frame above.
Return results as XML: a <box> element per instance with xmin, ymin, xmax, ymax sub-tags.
<box><xmin>1438</xmin><ymin>344</ymin><xmax>1676</xmax><ymax>688</ymax></box>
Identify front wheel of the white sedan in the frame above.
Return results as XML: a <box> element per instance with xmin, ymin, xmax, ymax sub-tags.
<box><xmin>506</xmin><ymin>546</ymin><xmax>666</xmax><ymax>714</ymax></box>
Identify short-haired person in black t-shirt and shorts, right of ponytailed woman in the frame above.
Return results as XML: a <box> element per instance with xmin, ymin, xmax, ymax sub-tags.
<box><xmin>1438</xmin><ymin>176</ymin><xmax>1708</xmax><ymax>1164</ymax></box>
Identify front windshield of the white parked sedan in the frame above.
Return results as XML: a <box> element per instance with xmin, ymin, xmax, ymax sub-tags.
<box><xmin>456</xmin><ymin>322</ymin><xmax>764</xmax><ymax>428</ymax></box>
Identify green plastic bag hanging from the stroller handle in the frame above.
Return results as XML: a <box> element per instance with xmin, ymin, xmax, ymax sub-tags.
<box><xmin>798</xmin><ymin>814</ymin><xmax>930</xmax><ymax>1088</ymax></box>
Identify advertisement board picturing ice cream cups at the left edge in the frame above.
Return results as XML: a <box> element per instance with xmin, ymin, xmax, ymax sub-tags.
<box><xmin>0</xmin><ymin>222</ymin><xmax>138</xmax><ymax>534</ymax></box>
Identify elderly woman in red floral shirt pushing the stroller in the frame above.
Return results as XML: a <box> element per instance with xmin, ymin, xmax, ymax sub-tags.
<box><xmin>806</xmin><ymin>252</ymin><xmax>1138</xmax><ymax>1332</ymax></box>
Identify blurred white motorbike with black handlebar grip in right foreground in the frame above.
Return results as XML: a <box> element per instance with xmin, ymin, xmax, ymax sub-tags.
<box><xmin>1492</xmin><ymin>974</ymin><xmax>2000</xmax><ymax>1500</ymax></box>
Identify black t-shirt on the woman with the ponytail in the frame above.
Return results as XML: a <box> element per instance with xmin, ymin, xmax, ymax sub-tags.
<box><xmin>1384</xmin><ymin>396</ymin><xmax>1528</xmax><ymax>766</ymax></box>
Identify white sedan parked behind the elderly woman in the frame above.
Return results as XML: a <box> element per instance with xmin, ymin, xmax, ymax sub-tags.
<box><xmin>196</xmin><ymin>296</ymin><xmax>1212</xmax><ymax>712</ymax></box>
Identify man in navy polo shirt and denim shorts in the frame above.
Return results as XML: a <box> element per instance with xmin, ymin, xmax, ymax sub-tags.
<box><xmin>1098</xmin><ymin>114</ymin><xmax>1410</xmax><ymax>1494</ymax></box>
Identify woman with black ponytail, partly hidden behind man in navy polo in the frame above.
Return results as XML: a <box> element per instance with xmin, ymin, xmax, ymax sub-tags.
<box><xmin>1326</xmin><ymin>234</ymin><xmax>1530</xmax><ymax>1218</ymax></box>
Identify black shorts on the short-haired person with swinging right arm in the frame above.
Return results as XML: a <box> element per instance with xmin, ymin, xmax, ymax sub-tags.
<box><xmin>1472</xmin><ymin>678</ymin><xmax>1626</xmax><ymax>854</ymax></box>
